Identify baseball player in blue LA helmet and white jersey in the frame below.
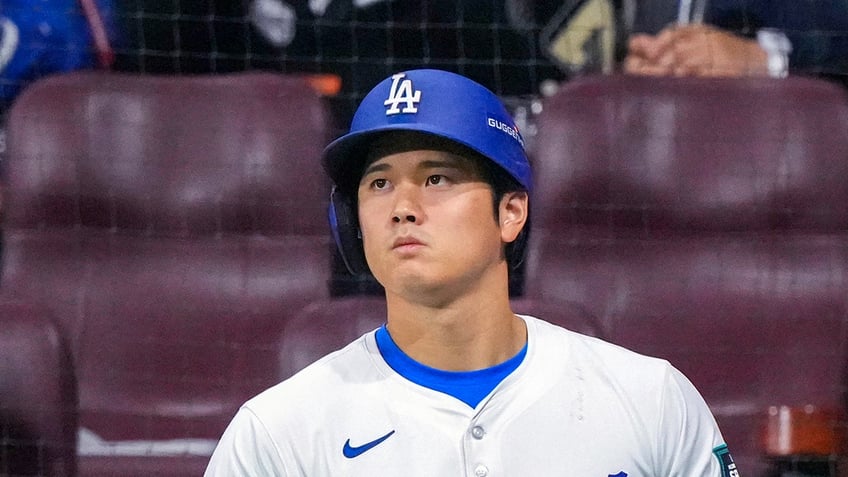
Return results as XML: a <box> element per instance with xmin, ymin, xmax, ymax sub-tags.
<box><xmin>206</xmin><ymin>70</ymin><xmax>738</xmax><ymax>477</ymax></box>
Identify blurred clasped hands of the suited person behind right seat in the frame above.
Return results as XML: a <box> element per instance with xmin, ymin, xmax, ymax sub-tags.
<box><xmin>624</xmin><ymin>25</ymin><xmax>768</xmax><ymax>77</ymax></box>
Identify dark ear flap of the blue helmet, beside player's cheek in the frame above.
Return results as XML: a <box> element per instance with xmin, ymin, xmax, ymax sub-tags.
<box><xmin>329</xmin><ymin>187</ymin><xmax>370</xmax><ymax>275</ymax></box>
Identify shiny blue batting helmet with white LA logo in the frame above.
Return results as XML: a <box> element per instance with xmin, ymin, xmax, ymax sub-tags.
<box><xmin>322</xmin><ymin>69</ymin><xmax>532</xmax><ymax>274</ymax></box>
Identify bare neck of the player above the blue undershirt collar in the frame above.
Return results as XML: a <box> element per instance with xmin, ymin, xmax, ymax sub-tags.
<box><xmin>386</xmin><ymin>268</ymin><xmax>527</xmax><ymax>371</ymax></box>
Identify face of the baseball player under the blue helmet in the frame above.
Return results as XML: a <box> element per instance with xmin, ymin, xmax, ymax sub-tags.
<box><xmin>358</xmin><ymin>150</ymin><xmax>504</xmax><ymax>298</ymax></box>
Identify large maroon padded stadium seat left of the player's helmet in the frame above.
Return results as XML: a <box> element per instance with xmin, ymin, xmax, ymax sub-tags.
<box><xmin>0</xmin><ymin>73</ymin><xmax>332</xmax><ymax>476</ymax></box>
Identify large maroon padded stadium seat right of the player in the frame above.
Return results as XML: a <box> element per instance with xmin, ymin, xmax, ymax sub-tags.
<box><xmin>526</xmin><ymin>76</ymin><xmax>848</xmax><ymax>476</ymax></box>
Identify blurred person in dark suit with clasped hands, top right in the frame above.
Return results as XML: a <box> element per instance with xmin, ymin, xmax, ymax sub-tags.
<box><xmin>624</xmin><ymin>0</ymin><xmax>848</xmax><ymax>80</ymax></box>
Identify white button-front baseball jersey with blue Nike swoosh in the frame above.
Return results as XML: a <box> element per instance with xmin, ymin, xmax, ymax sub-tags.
<box><xmin>206</xmin><ymin>316</ymin><xmax>738</xmax><ymax>477</ymax></box>
